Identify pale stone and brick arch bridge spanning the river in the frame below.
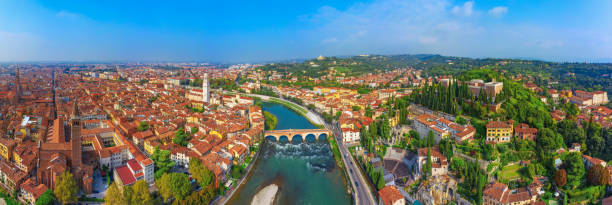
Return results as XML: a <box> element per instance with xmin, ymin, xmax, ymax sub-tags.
<box><xmin>264</xmin><ymin>129</ymin><xmax>332</xmax><ymax>142</ymax></box>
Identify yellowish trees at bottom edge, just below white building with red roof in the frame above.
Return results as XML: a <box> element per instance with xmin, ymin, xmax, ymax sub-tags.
<box><xmin>104</xmin><ymin>180</ymin><xmax>155</xmax><ymax>205</ymax></box>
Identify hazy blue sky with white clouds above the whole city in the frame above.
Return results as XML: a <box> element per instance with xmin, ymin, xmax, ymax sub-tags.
<box><xmin>0</xmin><ymin>0</ymin><xmax>612</xmax><ymax>62</ymax></box>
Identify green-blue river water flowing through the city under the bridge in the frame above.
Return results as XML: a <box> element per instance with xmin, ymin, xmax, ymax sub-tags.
<box><xmin>228</xmin><ymin>103</ymin><xmax>351</xmax><ymax>205</ymax></box>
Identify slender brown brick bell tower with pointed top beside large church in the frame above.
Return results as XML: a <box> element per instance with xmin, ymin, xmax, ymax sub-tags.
<box><xmin>70</xmin><ymin>99</ymin><xmax>83</xmax><ymax>170</ymax></box>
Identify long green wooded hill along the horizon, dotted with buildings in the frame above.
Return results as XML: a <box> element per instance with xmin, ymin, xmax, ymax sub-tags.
<box><xmin>259</xmin><ymin>54</ymin><xmax>612</xmax><ymax>93</ymax></box>
